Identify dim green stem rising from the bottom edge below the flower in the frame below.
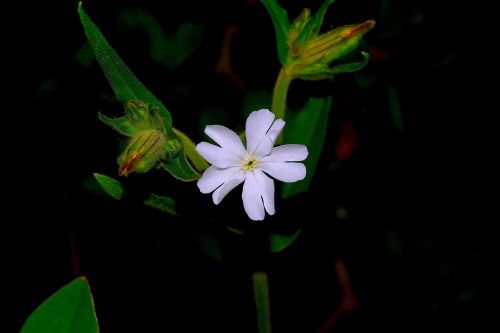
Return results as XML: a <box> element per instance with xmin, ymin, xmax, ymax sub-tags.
<box><xmin>252</xmin><ymin>272</ymin><xmax>271</xmax><ymax>333</ymax></box>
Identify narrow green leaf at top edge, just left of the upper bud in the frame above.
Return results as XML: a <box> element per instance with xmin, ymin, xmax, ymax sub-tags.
<box><xmin>261</xmin><ymin>0</ymin><xmax>290</xmax><ymax>65</ymax></box>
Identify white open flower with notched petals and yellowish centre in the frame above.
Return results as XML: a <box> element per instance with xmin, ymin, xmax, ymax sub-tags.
<box><xmin>196</xmin><ymin>109</ymin><xmax>308</xmax><ymax>221</ymax></box>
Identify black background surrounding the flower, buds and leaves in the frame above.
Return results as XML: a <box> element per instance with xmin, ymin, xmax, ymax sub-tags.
<box><xmin>0</xmin><ymin>0</ymin><xmax>496</xmax><ymax>332</ymax></box>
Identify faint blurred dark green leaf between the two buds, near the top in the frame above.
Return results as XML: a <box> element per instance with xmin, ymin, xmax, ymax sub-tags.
<box><xmin>118</xmin><ymin>8</ymin><xmax>204</xmax><ymax>69</ymax></box>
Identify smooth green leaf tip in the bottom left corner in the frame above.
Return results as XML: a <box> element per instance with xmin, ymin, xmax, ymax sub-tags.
<box><xmin>21</xmin><ymin>277</ymin><xmax>99</xmax><ymax>333</ymax></box>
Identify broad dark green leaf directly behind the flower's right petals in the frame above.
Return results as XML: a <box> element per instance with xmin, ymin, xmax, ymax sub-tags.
<box><xmin>281</xmin><ymin>96</ymin><xmax>332</xmax><ymax>199</ymax></box>
